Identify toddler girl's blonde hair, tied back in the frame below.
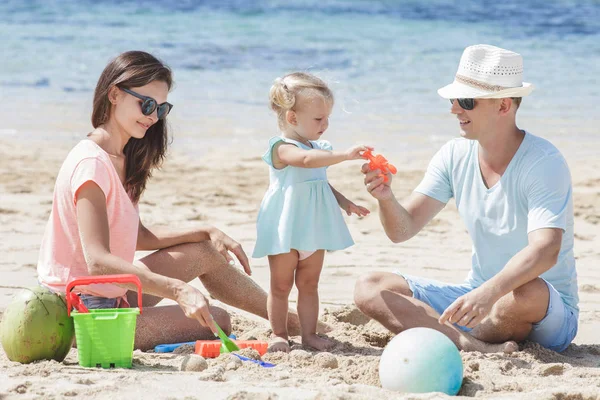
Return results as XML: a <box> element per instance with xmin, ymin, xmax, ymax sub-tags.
<box><xmin>269</xmin><ymin>72</ymin><xmax>333</xmax><ymax>129</ymax></box>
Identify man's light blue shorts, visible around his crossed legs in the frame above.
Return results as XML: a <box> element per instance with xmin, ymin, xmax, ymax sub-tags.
<box><xmin>396</xmin><ymin>272</ymin><xmax>578</xmax><ymax>352</ymax></box>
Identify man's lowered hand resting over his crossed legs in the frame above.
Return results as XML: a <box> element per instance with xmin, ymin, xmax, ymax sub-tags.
<box><xmin>439</xmin><ymin>287</ymin><xmax>499</xmax><ymax>328</ymax></box>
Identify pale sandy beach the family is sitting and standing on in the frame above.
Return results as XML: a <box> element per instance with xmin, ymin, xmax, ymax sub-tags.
<box><xmin>0</xmin><ymin>137</ymin><xmax>600</xmax><ymax>400</ymax></box>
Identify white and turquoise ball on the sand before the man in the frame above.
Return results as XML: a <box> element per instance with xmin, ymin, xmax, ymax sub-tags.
<box><xmin>379</xmin><ymin>328</ymin><xmax>463</xmax><ymax>396</ymax></box>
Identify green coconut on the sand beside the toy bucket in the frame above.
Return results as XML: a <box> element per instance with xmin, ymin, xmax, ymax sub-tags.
<box><xmin>0</xmin><ymin>286</ymin><xmax>75</xmax><ymax>363</ymax></box>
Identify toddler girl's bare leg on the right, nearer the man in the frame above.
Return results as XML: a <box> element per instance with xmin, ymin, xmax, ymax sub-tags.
<box><xmin>296</xmin><ymin>250</ymin><xmax>333</xmax><ymax>351</ymax></box>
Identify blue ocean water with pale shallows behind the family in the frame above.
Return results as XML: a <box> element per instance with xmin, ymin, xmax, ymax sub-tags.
<box><xmin>0</xmin><ymin>0</ymin><xmax>600</xmax><ymax>155</ymax></box>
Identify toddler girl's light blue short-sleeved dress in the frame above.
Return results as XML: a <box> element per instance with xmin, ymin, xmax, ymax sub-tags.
<box><xmin>252</xmin><ymin>136</ymin><xmax>354</xmax><ymax>258</ymax></box>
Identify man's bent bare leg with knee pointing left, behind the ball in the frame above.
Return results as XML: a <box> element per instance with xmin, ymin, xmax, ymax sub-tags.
<box><xmin>354</xmin><ymin>272</ymin><xmax>518</xmax><ymax>353</ymax></box>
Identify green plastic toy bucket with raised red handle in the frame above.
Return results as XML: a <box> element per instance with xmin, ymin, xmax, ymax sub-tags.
<box><xmin>67</xmin><ymin>275</ymin><xmax>142</xmax><ymax>368</ymax></box>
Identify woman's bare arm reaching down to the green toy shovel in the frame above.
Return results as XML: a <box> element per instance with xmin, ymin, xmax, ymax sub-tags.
<box><xmin>76</xmin><ymin>181</ymin><xmax>216</xmax><ymax>332</ymax></box>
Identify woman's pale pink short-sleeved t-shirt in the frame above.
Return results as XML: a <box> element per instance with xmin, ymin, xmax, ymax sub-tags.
<box><xmin>37</xmin><ymin>140</ymin><xmax>139</xmax><ymax>298</ymax></box>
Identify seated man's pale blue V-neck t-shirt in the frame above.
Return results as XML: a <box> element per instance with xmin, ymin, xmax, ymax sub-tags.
<box><xmin>415</xmin><ymin>133</ymin><xmax>579</xmax><ymax>311</ymax></box>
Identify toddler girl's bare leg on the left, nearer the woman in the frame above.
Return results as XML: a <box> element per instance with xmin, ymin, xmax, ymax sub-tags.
<box><xmin>267</xmin><ymin>251</ymin><xmax>298</xmax><ymax>352</ymax></box>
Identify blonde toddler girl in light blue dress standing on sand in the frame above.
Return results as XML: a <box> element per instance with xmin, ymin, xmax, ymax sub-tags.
<box><xmin>253</xmin><ymin>72</ymin><xmax>370</xmax><ymax>352</ymax></box>
